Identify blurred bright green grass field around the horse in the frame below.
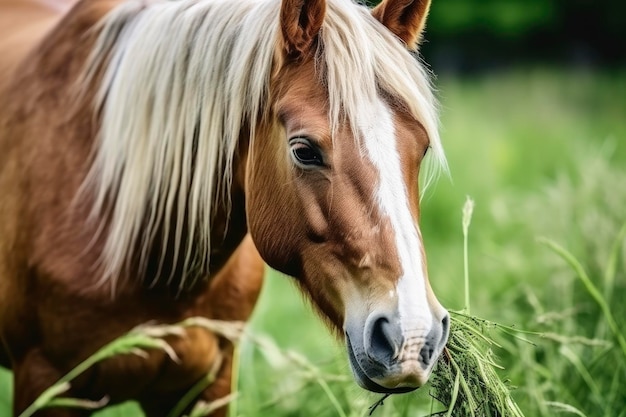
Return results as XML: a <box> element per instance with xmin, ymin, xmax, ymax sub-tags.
<box><xmin>0</xmin><ymin>68</ymin><xmax>626</xmax><ymax>417</ymax></box>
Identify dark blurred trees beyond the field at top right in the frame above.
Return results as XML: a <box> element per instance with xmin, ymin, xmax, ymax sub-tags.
<box><xmin>366</xmin><ymin>0</ymin><xmax>626</xmax><ymax>73</ymax></box>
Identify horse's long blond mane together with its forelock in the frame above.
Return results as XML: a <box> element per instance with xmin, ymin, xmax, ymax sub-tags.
<box><xmin>83</xmin><ymin>0</ymin><xmax>445</xmax><ymax>289</ymax></box>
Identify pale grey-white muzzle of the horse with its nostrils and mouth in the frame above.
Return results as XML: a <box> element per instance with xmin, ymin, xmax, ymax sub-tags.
<box><xmin>345</xmin><ymin>310</ymin><xmax>450</xmax><ymax>394</ymax></box>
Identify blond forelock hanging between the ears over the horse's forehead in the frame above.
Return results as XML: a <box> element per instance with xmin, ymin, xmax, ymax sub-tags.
<box><xmin>318</xmin><ymin>0</ymin><xmax>447</xmax><ymax>184</ymax></box>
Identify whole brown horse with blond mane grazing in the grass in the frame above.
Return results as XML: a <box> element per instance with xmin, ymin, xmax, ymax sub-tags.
<box><xmin>0</xmin><ymin>0</ymin><xmax>449</xmax><ymax>417</ymax></box>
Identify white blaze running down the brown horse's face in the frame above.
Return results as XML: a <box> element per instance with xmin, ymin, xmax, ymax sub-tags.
<box><xmin>359</xmin><ymin>100</ymin><xmax>433</xmax><ymax>337</ymax></box>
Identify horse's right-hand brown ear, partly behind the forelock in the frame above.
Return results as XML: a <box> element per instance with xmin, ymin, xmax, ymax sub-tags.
<box><xmin>372</xmin><ymin>0</ymin><xmax>430</xmax><ymax>49</ymax></box>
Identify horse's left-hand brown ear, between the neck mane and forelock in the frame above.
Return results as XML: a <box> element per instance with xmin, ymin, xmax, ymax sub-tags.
<box><xmin>280</xmin><ymin>0</ymin><xmax>326</xmax><ymax>58</ymax></box>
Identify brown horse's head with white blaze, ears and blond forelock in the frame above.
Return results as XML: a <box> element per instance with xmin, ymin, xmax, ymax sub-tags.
<box><xmin>246</xmin><ymin>0</ymin><xmax>449</xmax><ymax>393</ymax></box>
